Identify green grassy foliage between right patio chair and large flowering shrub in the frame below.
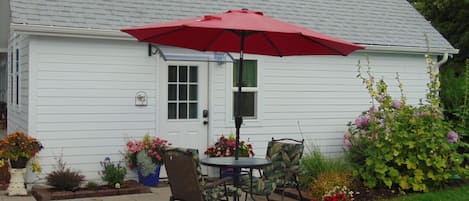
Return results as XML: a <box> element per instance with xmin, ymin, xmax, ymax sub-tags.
<box><xmin>299</xmin><ymin>145</ymin><xmax>351</xmax><ymax>189</ymax></box>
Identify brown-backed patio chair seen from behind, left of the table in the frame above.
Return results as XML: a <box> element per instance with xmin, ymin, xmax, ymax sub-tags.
<box><xmin>164</xmin><ymin>148</ymin><xmax>235</xmax><ymax>201</ymax></box>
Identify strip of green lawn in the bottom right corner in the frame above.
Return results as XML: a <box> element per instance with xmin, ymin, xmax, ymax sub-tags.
<box><xmin>382</xmin><ymin>185</ymin><xmax>469</xmax><ymax>201</ymax></box>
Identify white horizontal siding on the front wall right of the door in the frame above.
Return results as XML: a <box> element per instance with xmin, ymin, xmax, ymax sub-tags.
<box><xmin>211</xmin><ymin>53</ymin><xmax>428</xmax><ymax>157</ymax></box>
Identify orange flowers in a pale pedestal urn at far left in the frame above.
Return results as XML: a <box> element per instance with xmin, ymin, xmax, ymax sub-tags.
<box><xmin>0</xmin><ymin>132</ymin><xmax>43</xmax><ymax>195</ymax></box>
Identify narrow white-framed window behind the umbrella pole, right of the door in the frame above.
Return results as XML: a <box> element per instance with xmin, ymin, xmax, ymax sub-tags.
<box><xmin>233</xmin><ymin>60</ymin><xmax>258</xmax><ymax>119</ymax></box>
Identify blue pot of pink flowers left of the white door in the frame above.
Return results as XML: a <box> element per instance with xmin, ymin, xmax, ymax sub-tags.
<box><xmin>125</xmin><ymin>134</ymin><xmax>170</xmax><ymax>186</ymax></box>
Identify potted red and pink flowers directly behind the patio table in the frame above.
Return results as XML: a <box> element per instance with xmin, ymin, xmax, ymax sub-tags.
<box><xmin>204</xmin><ymin>134</ymin><xmax>254</xmax><ymax>177</ymax></box>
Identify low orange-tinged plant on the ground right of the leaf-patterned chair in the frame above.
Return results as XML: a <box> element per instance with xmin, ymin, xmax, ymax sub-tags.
<box><xmin>310</xmin><ymin>171</ymin><xmax>353</xmax><ymax>200</ymax></box>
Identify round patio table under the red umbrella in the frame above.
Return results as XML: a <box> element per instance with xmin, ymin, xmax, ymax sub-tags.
<box><xmin>200</xmin><ymin>157</ymin><xmax>272</xmax><ymax>201</ymax></box>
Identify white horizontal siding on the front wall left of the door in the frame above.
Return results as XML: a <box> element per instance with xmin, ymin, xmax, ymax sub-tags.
<box><xmin>31</xmin><ymin>37</ymin><xmax>156</xmax><ymax>179</ymax></box>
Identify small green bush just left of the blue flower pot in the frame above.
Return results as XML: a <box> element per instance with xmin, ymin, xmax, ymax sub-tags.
<box><xmin>100</xmin><ymin>157</ymin><xmax>127</xmax><ymax>187</ymax></box>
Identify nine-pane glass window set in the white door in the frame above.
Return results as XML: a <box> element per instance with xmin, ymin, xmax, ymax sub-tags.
<box><xmin>168</xmin><ymin>65</ymin><xmax>199</xmax><ymax>119</ymax></box>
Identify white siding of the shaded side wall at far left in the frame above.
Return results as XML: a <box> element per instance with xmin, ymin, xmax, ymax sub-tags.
<box><xmin>7</xmin><ymin>34</ymin><xmax>29</xmax><ymax>136</ymax></box>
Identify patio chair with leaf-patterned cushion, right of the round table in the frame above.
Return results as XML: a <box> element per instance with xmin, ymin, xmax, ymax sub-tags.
<box><xmin>242</xmin><ymin>138</ymin><xmax>304</xmax><ymax>200</ymax></box>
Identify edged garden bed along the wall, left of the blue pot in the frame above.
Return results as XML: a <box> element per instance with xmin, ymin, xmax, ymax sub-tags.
<box><xmin>31</xmin><ymin>180</ymin><xmax>151</xmax><ymax>201</ymax></box>
